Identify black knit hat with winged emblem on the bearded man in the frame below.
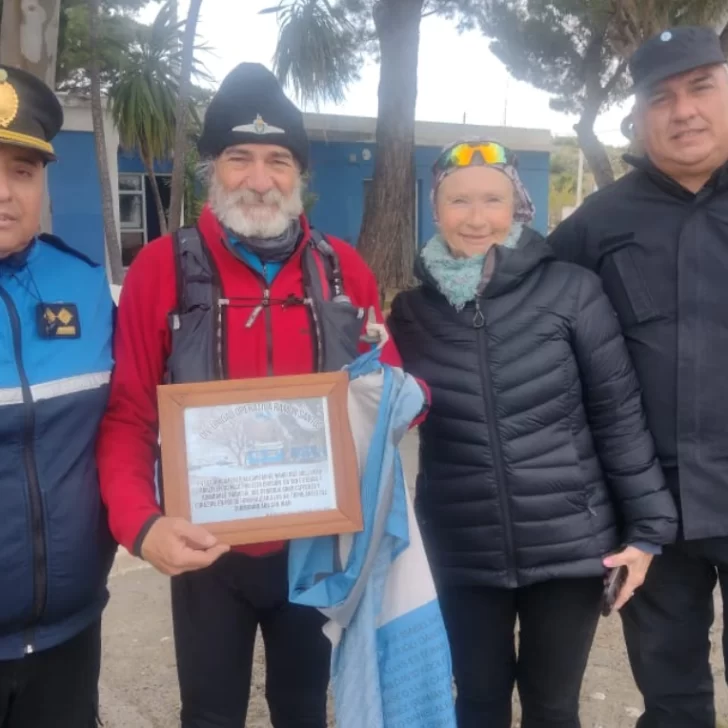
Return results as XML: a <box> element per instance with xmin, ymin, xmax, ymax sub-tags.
<box><xmin>197</xmin><ymin>63</ymin><xmax>308</xmax><ymax>171</ymax></box>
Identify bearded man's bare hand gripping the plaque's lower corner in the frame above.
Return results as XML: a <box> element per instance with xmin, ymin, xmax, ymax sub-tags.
<box><xmin>141</xmin><ymin>516</ymin><xmax>230</xmax><ymax>576</ymax></box>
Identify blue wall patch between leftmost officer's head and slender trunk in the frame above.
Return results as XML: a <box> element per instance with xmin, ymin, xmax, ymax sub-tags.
<box><xmin>48</xmin><ymin>131</ymin><xmax>104</xmax><ymax>263</ymax></box>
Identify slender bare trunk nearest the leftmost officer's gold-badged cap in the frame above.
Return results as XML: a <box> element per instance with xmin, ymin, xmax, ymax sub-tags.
<box><xmin>88</xmin><ymin>0</ymin><xmax>124</xmax><ymax>285</ymax></box>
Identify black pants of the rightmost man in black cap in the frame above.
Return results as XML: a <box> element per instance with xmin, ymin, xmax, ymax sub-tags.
<box><xmin>622</xmin><ymin>539</ymin><xmax>728</xmax><ymax>728</ymax></box>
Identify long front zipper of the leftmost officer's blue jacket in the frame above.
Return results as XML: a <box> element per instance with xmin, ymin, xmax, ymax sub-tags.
<box><xmin>0</xmin><ymin>286</ymin><xmax>48</xmax><ymax>655</ymax></box>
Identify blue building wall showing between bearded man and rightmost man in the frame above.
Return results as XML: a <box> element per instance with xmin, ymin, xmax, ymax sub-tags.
<box><xmin>310</xmin><ymin>142</ymin><xmax>549</xmax><ymax>245</ymax></box>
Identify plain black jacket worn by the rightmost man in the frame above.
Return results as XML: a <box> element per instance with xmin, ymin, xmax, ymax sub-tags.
<box><xmin>549</xmin><ymin>157</ymin><xmax>728</xmax><ymax>539</ymax></box>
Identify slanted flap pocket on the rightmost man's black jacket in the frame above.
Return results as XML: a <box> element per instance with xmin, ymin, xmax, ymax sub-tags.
<box><xmin>601</xmin><ymin>245</ymin><xmax>659</xmax><ymax>327</ymax></box>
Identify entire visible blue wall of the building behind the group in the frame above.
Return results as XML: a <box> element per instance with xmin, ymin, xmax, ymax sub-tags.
<box><xmin>49</xmin><ymin>131</ymin><xmax>549</xmax><ymax>262</ymax></box>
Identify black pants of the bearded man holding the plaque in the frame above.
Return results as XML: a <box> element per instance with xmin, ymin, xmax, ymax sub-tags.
<box><xmin>172</xmin><ymin>552</ymin><xmax>331</xmax><ymax>728</ymax></box>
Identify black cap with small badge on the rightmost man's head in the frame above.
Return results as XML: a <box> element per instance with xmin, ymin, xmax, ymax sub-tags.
<box><xmin>629</xmin><ymin>25</ymin><xmax>726</xmax><ymax>93</ymax></box>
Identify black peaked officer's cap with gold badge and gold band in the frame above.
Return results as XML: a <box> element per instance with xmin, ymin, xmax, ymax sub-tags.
<box><xmin>0</xmin><ymin>65</ymin><xmax>63</xmax><ymax>162</ymax></box>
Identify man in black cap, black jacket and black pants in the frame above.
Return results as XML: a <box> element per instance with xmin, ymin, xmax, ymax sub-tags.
<box><xmin>550</xmin><ymin>28</ymin><xmax>728</xmax><ymax>728</ymax></box>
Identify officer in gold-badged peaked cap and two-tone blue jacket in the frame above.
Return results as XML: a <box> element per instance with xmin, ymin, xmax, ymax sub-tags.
<box><xmin>0</xmin><ymin>66</ymin><xmax>114</xmax><ymax>728</ymax></box>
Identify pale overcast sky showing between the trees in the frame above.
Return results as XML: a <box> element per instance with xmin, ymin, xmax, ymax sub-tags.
<box><xmin>143</xmin><ymin>0</ymin><xmax>627</xmax><ymax>144</ymax></box>
